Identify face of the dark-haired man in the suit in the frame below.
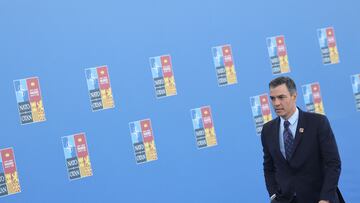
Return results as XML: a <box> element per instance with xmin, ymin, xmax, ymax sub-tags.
<box><xmin>270</xmin><ymin>84</ymin><xmax>297</xmax><ymax>120</ymax></box>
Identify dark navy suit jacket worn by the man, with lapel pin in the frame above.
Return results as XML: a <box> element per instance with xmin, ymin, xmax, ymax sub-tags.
<box><xmin>261</xmin><ymin>109</ymin><xmax>342</xmax><ymax>203</ymax></box>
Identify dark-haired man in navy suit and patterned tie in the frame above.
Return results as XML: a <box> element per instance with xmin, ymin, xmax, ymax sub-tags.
<box><xmin>261</xmin><ymin>77</ymin><xmax>344</xmax><ymax>203</ymax></box>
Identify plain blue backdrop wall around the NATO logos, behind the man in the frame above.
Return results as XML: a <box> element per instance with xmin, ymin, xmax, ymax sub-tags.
<box><xmin>0</xmin><ymin>0</ymin><xmax>360</xmax><ymax>203</ymax></box>
